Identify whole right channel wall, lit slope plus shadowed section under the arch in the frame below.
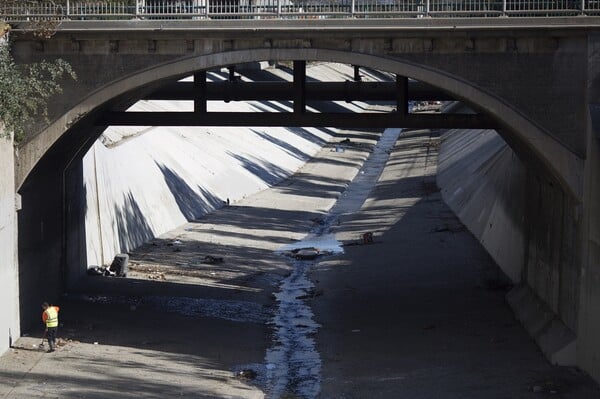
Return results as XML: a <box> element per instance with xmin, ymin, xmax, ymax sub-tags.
<box><xmin>438</xmin><ymin>126</ymin><xmax>580</xmax><ymax>365</ymax></box>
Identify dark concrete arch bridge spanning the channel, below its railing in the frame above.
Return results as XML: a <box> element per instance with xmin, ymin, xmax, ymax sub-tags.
<box><xmin>0</xmin><ymin>16</ymin><xmax>600</xmax><ymax>379</ymax></box>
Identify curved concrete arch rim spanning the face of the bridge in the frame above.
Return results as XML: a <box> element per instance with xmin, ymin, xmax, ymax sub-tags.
<box><xmin>16</xmin><ymin>48</ymin><xmax>583</xmax><ymax>200</ymax></box>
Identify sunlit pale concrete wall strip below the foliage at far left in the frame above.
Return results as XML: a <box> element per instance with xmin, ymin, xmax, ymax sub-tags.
<box><xmin>0</xmin><ymin>126</ymin><xmax>21</xmax><ymax>353</ymax></box>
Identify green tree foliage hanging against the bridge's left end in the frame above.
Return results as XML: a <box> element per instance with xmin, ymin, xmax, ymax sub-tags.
<box><xmin>0</xmin><ymin>30</ymin><xmax>77</xmax><ymax>143</ymax></box>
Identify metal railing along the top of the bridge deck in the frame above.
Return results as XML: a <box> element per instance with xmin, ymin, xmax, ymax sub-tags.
<box><xmin>0</xmin><ymin>0</ymin><xmax>600</xmax><ymax>22</ymax></box>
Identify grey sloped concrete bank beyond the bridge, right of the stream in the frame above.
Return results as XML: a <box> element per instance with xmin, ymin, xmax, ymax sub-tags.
<box><xmin>437</xmin><ymin>130</ymin><xmax>526</xmax><ymax>283</ymax></box>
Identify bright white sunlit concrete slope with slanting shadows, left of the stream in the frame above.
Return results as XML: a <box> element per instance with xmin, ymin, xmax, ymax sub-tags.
<box><xmin>84</xmin><ymin>64</ymin><xmax>382</xmax><ymax>266</ymax></box>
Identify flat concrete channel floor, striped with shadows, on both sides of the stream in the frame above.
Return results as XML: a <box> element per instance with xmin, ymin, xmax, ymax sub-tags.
<box><xmin>0</xmin><ymin>131</ymin><xmax>600</xmax><ymax>398</ymax></box>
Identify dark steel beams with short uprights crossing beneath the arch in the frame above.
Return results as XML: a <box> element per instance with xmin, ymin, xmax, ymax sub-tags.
<box><xmin>96</xmin><ymin>61</ymin><xmax>497</xmax><ymax>129</ymax></box>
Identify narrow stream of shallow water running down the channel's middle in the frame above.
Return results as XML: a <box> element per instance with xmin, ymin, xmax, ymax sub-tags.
<box><xmin>264</xmin><ymin>129</ymin><xmax>401</xmax><ymax>399</ymax></box>
